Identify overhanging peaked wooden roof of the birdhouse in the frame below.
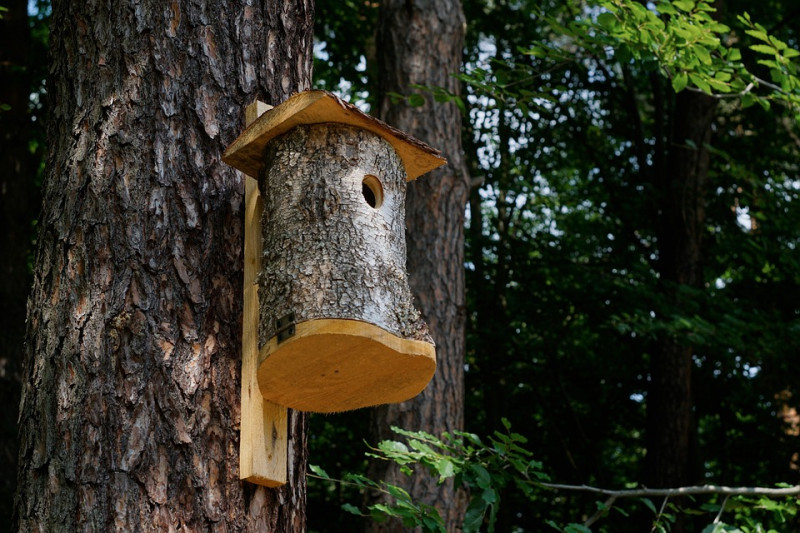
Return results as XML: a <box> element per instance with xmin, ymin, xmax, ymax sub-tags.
<box><xmin>222</xmin><ymin>91</ymin><xmax>447</xmax><ymax>181</ymax></box>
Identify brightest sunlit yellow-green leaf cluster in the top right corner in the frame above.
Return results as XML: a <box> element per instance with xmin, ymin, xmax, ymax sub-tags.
<box><xmin>582</xmin><ymin>0</ymin><xmax>800</xmax><ymax>112</ymax></box>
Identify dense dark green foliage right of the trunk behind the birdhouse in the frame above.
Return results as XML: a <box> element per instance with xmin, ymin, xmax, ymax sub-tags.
<box><xmin>312</xmin><ymin>0</ymin><xmax>800</xmax><ymax>531</ymax></box>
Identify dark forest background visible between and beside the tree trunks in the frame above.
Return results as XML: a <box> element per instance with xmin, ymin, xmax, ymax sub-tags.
<box><xmin>0</xmin><ymin>0</ymin><xmax>800</xmax><ymax>531</ymax></box>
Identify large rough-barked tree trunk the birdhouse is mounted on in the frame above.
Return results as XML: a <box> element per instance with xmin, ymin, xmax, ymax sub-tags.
<box><xmin>17</xmin><ymin>0</ymin><xmax>313</xmax><ymax>531</ymax></box>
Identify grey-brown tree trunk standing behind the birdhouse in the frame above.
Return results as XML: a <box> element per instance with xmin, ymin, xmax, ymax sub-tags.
<box><xmin>368</xmin><ymin>0</ymin><xmax>470</xmax><ymax>531</ymax></box>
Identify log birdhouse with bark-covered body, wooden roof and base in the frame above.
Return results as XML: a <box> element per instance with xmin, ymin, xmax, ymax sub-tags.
<box><xmin>223</xmin><ymin>91</ymin><xmax>445</xmax><ymax>482</ymax></box>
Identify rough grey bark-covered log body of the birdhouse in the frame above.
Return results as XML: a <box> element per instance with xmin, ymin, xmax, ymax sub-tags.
<box><xmin>259</xmin><ymin>124</ymin><xmax>431</xmax><ymax>344</ymax></box>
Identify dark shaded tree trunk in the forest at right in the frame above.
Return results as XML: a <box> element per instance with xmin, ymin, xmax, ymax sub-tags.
<box><xmin>645</xmin><ymin>91</ymin><xmax>716</xmax><ymax>487</ymax></box>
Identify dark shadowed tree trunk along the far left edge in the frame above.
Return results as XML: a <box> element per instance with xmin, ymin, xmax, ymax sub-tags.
<box><xmin>0</xmin><ymin>0</ymin><xmax>37</xmax><ymax>531</ymax></box>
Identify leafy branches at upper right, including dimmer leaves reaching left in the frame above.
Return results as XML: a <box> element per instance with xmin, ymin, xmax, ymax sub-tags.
<box><xmin>461</xmin><ymin>0</ymin><xmax>800</xmax><ymax>120</ymax></box>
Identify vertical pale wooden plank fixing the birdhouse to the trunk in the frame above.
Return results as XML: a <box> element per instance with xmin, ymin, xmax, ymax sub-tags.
<box><xmin>239</xmin><ymin>100</ymin><xmax>288</xmax><ymax>487</ymax></box>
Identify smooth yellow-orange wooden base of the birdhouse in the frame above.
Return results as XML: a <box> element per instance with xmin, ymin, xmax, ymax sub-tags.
<box><xmin>258</xmin><ymin>319</ymin><xmax>436</xmax><ymax>413</ymax></box>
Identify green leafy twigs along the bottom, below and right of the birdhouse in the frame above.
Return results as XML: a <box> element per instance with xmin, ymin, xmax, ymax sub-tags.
<box><xmin>309</xmin><ymin>420</ymin><xmax>800</xmax><ymax>533</ymax></box>
